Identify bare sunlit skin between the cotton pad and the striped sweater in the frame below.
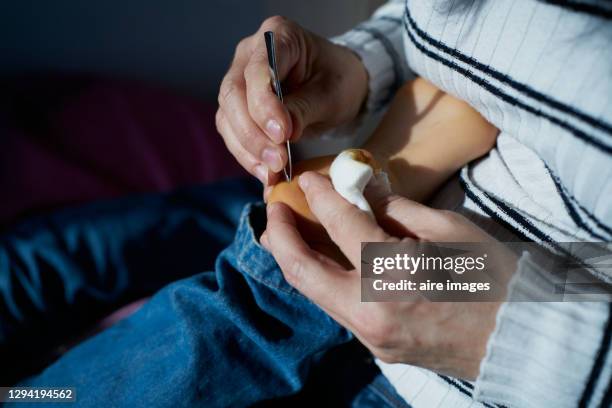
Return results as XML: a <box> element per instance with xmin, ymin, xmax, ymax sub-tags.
<box><xmin>364</xmin><ymin>78</ymin><xmax>499</xmax><ymax>202</ymax></box>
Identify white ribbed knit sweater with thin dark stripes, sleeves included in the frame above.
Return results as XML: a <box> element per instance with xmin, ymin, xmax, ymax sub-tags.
<box><xmin>334</xmin><ymin>0</ymin><xmax>612</xmax><ymax>408</ymax></box>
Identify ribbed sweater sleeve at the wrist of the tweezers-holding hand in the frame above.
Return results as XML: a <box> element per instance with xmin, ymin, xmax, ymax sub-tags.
<box><xmin>331</xmin><ymin>0</ymin><xmax>409</xmax><ymax>112</ymax></box>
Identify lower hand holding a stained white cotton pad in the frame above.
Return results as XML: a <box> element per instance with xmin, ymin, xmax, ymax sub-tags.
<box><xmin>261</xmin><ymin>172</ymin><xmax>510</xmax><ymax>379</ymax></box>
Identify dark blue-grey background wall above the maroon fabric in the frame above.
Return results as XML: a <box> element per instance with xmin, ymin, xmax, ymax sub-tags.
<box><xmin>0</xmin><ymin>0</ymin><xmax>381</xmax><ymax>100</ymax></box>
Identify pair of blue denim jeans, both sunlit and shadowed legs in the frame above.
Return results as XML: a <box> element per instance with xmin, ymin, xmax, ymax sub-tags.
<box><xmin>0</xmin><ymin>181</ymin><xmax>412</xmax><ymax>407</ymax></box>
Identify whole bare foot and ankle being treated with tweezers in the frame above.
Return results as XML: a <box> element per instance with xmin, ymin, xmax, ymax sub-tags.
<box><xmin>266</xmin><ymin>79</ymin><xmax>498</xmax><ymax>264</ymax></box>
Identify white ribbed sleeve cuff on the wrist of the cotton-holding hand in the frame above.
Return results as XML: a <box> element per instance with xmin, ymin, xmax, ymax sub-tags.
<box><xmin>474</xmin><ymin>254</ymin><xmax>612</xmax><ymax>408</ymax></box>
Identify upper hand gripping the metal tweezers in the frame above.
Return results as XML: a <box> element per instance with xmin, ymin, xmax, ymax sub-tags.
<box><xmin>216</xmin><ymin>17</ymin><xmax>368</xmax><ymax>185</ymax></box>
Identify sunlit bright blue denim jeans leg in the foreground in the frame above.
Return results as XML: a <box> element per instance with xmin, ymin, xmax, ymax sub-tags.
<box><xmin>21</xmin><ymin>205</ymin><xmax>351</xmax><ymax>406</ymax></box>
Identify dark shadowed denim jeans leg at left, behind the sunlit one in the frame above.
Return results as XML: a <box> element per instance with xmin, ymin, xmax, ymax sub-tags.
<box><xmin>0</xmin><ymin>180</ymin><xmax>261</xmax><ymax>384</ymax></box>
